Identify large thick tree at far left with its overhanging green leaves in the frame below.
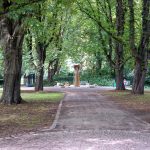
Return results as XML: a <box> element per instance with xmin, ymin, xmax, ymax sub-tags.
<box><xmin>0</xmin><ymin>0</ymin><xmax>45</xmax><ymax>104</ymax></box>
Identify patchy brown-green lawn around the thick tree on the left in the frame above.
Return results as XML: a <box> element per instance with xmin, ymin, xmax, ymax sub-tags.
<box><xmin>0</xmin><ymin>92</ymin><xmax>64</xmax><ymax>137</ymax></box>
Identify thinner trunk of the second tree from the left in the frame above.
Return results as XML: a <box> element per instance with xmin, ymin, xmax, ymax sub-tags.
<box><xmin>35</xmin><ymin>43</ymin><xmax>46</xmax><ymax>91</ymax></box>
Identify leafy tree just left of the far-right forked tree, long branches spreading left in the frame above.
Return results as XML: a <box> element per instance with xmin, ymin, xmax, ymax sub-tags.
<box><xmin>78</xmin><ymin>0</ymin><xmax>126</xmax><ymax>90</ymax></box>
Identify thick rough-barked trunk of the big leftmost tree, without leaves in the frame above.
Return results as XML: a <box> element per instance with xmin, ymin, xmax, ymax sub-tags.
<box><xmin>0</xmin><ymin>18</ymin><xmax>24</xmax><ymax>104</ymax></box>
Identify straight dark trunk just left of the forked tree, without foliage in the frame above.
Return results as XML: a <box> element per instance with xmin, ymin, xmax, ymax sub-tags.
<box><xmin>116</xmin><ymin>0</ymin><xmax>125</xmax><ymax>90</ymax></box>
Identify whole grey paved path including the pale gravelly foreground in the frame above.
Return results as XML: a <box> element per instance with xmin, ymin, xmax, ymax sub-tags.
<box><xmin>0</xmin><ymin>88</ymin><xmax>150</xmax><ymax>150</ymax></box>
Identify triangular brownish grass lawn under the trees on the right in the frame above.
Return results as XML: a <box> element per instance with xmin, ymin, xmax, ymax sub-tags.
<box><xmin>102</xmin><ymin>90</ymin><xmax>150</xmax><ymax>123</ymax></box>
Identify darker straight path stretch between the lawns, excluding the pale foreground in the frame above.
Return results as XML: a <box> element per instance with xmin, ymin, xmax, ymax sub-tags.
<box><xmin>53</xmin><ymin>89</ymin><xmax>149</xmax><ymax>131</ymax></box>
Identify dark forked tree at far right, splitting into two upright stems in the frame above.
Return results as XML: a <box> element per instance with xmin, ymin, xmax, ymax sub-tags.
<box><xmin>128</xmin><ymin>0</ymin><xmax>150</xmax><ymax>94</ymax></box>
